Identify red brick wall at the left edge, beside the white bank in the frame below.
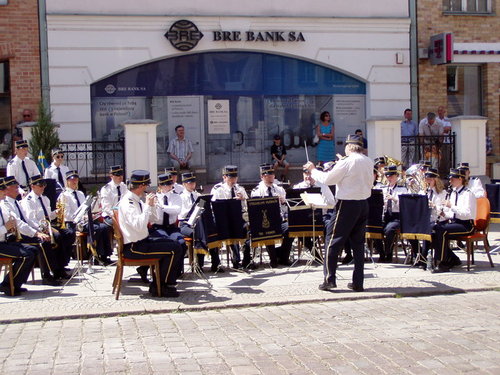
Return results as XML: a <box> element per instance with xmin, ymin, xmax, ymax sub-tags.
<box><xmin>0</xmin><ymin>0</ymin><xmax>41</xmax><ymax>124</ymax></box>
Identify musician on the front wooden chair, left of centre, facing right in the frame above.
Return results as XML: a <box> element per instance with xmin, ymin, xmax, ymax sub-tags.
<box><xmin>118</xmin><ymin>170</ymin><xmax>183</xmax><ymax>297</ymax></box>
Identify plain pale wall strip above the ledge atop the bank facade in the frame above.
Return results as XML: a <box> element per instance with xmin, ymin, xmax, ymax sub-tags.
<box><xmin>46</xmin><ymin>0</ymin><xmax>408</xmax><ymax>17</ymax></box>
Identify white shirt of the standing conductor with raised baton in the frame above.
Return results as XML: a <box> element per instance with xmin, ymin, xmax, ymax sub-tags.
<box><xmin>311</xmin><ymin>152</ymin><xmax>373</xmax><ymax>200</ymax></box>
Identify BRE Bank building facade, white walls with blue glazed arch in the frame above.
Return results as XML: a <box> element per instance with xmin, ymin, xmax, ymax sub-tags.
<box><xmin>46</xmin><ymin>0</ymin><xmax>414</xmax><ymax>183</ymax></box>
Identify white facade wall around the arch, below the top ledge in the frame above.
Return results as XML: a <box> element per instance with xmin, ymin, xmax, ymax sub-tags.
<box><xmin>47</xmin><ymin>13</ymin><xmax>410</xmax><ymax>140</ymax></box>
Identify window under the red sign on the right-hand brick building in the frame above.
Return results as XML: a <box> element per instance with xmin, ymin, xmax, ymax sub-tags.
<box><xmin>447</xmin><ymin>65</ymin><xmax>483</xmax><ymax>116</ymax></box>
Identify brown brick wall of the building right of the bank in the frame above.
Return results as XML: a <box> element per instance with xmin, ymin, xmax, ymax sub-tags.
<box><xmin>417</xmin><ymin>0</ymin><xmax>500</xmax><ymax>155</ymax></box>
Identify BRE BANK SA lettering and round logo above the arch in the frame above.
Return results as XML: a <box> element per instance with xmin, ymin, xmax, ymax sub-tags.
<box><xmin>165</xmin><ymin>20</ymin><xmax>306</xmax><ymax>51</ymax></box>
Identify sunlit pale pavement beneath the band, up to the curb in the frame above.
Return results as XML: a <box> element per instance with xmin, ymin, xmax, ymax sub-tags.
<box><xmin>0</xmin><ymin>229</ymin><xmax>500</xmax><ymax>323</ymax></box>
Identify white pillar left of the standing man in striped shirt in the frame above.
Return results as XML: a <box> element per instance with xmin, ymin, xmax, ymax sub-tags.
<box><xmin>121</xmin><ymin>120</ymin><xmax>159</xmax><ymax>186</ymax></box>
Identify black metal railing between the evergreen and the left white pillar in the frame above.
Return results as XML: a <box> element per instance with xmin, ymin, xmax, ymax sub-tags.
<box><xmin>60</xmin><ymin>140</ymin><xmax>125</xmax><ymax>184</ymax></box>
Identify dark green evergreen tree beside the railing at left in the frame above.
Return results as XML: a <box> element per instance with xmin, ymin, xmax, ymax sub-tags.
<box><xmin>29</xmin><ymin>101</ymin><xmax>59</xmax><ymax>168</ymax></box>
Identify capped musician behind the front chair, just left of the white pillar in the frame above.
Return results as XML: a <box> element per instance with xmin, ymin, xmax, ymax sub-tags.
<box><xmin>100</xmin><ymin>165</ymin><xmax>128</xmax><ymax>227</ymax></box>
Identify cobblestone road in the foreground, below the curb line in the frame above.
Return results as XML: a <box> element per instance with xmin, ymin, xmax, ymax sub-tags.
<box><xmin>0</xmin><ymin>291</ymin><xmax>500</xmax><ymax>375</ymax></box>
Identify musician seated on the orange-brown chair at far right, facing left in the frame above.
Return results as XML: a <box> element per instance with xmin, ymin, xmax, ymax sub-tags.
<box><xmin>432</xmin><ymin>168</ymin><xmax>476</xmax><ymax>273</ymax></box>
